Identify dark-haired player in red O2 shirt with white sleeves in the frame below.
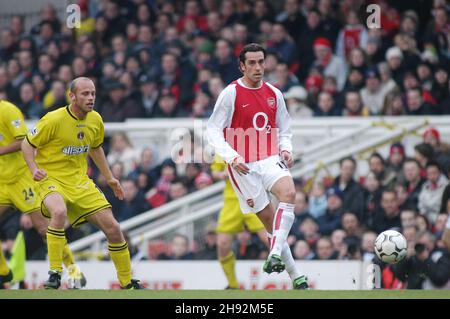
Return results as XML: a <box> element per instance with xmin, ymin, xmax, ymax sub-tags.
<box><xmin>207</xmin><ymin>43</ymin><xmax>309</xmax><ymax>289</ymax></box>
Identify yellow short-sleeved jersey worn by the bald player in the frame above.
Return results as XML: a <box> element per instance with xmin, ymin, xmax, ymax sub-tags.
<box><xmin>27</xmin><ymin>106</ymin><xmax>105</xmax><ymax>185</ymax></box>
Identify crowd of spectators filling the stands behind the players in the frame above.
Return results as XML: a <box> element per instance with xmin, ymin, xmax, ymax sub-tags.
<box><xmin>0</xmin><ymin>0</ymin><xmax>450</xmax><ymax>287</ymax></box>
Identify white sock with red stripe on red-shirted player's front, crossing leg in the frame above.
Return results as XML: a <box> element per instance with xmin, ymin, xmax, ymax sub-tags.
<box><xmin>269</xmin><ymin>202</ymin><xmax>295</xmax><ymax>256</ymax></box>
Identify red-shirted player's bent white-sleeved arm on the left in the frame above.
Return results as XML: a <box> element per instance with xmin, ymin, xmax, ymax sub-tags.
<box><xmin>206</xmin><ymin>86</ymin><xmax>249</xmax><ymax>174</ymax></box>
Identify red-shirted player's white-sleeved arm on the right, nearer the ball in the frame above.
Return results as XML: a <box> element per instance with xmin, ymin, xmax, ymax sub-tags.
<box><xmin>276</xmin><ymin>91</ymin><xmax>294</xmax><ymax>167</ymax></box>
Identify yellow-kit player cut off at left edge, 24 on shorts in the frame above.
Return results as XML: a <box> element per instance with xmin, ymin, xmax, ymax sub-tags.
<box><xmin>0</xmin><ymin>101</ymin><xmax>86</xmax><ymax>289</ymax></box>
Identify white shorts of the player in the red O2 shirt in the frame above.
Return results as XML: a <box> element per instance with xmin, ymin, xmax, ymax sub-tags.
<box><xmin>228</xmin><ymin>155</ymin><xmax>291</xmax><ymax>214</ymax></box>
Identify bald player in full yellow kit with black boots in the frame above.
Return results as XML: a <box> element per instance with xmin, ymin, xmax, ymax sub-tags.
<box><xmin>22</xmin><ymin>77</ymin><xmax>142</xmax><ymax>289</ymax></box>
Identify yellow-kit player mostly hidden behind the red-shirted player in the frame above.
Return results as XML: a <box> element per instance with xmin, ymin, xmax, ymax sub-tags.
<box><xmin>211</xmin><ymin>155</ymin><xmax>267</xmax><ymax>289</ymax></box>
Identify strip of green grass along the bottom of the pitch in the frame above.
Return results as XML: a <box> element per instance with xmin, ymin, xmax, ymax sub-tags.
<box><xmin>0</xmin><ymin>290</ymin><xmax>450</xmax><ymax>299</ymax></box>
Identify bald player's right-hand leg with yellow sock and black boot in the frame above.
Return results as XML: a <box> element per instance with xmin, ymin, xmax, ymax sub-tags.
<box><xmin>86</xmin><ymin>208</ymin><xmax>142</xmax><ymax>289</ymax></box>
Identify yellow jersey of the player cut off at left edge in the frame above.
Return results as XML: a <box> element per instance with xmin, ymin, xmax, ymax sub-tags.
<box><xmin>0</xmin><ymin>100</ymin><xmax>28</xmax><ymax>184</ymax></box>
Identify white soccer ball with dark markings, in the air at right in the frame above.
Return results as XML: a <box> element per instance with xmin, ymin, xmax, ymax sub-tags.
<box><xmin>375</xmin><ymin>230</ymin><xmax>407</xmax><ymax>264</ymax></box>
